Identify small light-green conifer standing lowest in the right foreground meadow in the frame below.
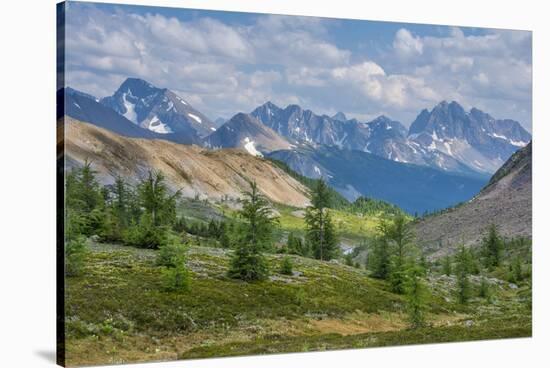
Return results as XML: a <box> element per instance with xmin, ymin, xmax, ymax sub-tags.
<box><xmin>405</xmin><ymin>266</ymin><xmax>428</xmax><ymax>329</ymax></box>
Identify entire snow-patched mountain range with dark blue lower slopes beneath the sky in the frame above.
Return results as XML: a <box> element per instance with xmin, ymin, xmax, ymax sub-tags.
<box><xmin>58</xmin><ymin>78</ymin><xmax>531</xmax><ymax>213</ymax></box>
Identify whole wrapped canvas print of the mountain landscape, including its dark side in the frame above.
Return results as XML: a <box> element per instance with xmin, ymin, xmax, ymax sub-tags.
<box><xmin>57</xmin><ymin>1</ymin><xmax>532</xmax><ymax>366</ymax></box>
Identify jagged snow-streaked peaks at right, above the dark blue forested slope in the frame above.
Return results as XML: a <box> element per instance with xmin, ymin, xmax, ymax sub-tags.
<box><xmin>251</xmin><ymin>101</ymin><xmax>531</xmax><ymax>175</ymax></box>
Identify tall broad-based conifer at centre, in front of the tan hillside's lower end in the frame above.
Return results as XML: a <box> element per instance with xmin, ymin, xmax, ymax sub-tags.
<box><xmin>228</xmin><ymin>182</ymin><xmax>277</xmax><ymax>281</ymax></box>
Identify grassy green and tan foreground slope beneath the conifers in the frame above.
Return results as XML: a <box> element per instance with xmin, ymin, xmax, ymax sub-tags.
<box><xmin>66</xmin><ymin>244</ymin><xmax>531</xmax><ymax>365</ymax></box>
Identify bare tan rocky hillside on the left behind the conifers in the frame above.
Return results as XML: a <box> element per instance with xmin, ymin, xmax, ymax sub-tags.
<box><xmin>65</xmin><ymin>118</ymin><xmax>308</xmax><ymax>207</ymax></box>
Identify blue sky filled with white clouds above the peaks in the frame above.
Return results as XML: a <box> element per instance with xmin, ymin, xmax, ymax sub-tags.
<box><xmin>66</xmin><ymin>2</ymin><xmax>532</xmax><ymax>131</ymax></box>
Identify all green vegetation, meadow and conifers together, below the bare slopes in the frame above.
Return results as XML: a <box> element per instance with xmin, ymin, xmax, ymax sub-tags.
<box><xmin>65</xmin><ymin>163</ymin><xmax>531</xmax><ymax>365</ymax></box>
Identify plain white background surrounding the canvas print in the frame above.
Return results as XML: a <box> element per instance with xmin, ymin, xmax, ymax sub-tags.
<box><xmin>0</xmin><ymin>0</ymin><xmax>550</xmax><ymax>368</ymax></box>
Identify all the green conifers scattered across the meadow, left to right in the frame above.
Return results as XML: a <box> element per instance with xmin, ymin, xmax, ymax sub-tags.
<box><xmin>65</xmin><ymin>162</ymin><xmax>525</xmax><ymax>328</ymax></box>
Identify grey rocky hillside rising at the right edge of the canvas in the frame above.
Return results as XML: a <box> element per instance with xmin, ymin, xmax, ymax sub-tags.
<box><xmin>414</xmin><ymin>143</ymin><xmax>532</xmax><ymax>258</ymax></box>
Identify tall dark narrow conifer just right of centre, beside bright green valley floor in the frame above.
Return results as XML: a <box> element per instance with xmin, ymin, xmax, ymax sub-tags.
<box><xmin>305</xmin><ymin>179</ymin><xmax>338</xmax><ymax>260</ymax></box>
